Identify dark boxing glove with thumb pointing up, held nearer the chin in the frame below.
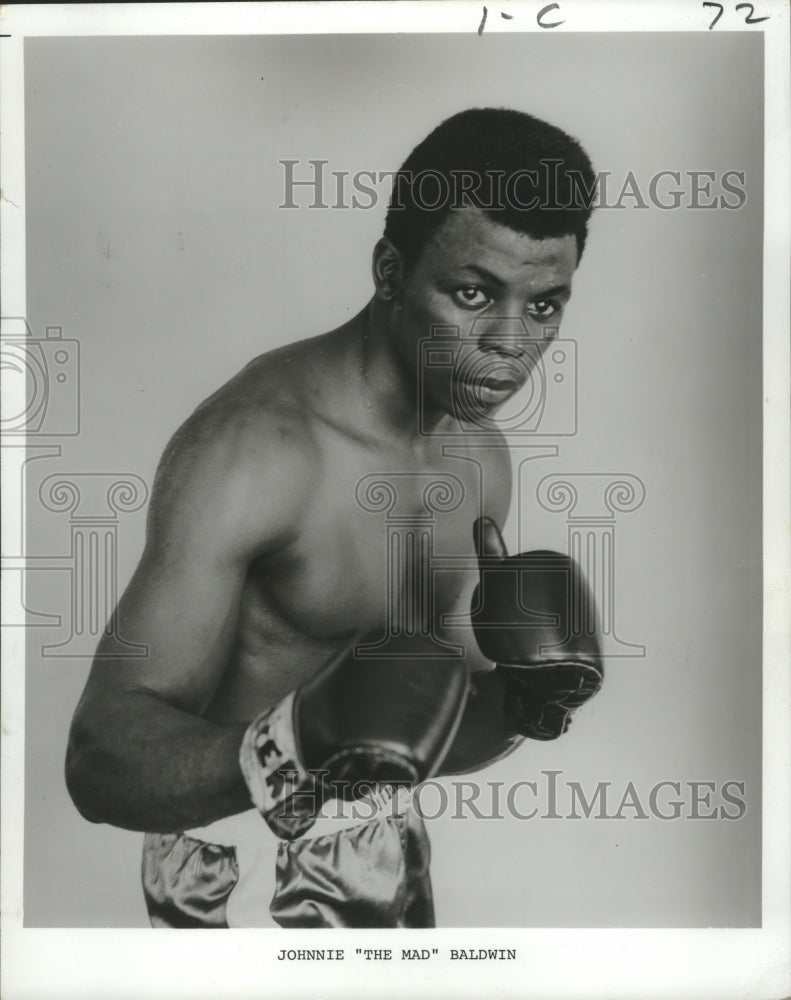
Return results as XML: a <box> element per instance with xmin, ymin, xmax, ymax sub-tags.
<box><xmin>471</xmin><ymin>517</ymin><xmax>604</xmax><ymax>740</ymax></box>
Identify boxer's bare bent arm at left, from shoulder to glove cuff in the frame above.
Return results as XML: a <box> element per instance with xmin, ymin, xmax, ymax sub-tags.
<box><xmin>66</xmin><ymin>402</ymin><xmax>312</xmax><ymax>832</ymax></box>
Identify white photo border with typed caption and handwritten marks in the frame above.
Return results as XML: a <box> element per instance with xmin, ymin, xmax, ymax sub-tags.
<box><xmin>0</xmin><ymin>0</ymin><xmax>791</xmax><ymax>1000</ymax></box>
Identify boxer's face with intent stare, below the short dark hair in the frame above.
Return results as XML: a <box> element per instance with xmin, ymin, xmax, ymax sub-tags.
<box><xmin>391</xmin><ymin>208</ymin><xmax>577</xmax><ymax>417</ymax></box>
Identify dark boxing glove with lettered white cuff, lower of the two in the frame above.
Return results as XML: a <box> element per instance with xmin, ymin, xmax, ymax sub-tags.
<box><xmin>239</xmin><ymin>638</ymin><xmax>469</xmax><ymax>837</ymax></box>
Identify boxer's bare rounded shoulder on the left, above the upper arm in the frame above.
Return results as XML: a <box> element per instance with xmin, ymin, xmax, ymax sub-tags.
<box><xmin>149</xmin><ymin>352</ymin><xmax>319</xmax><ymax>559</ymax></box>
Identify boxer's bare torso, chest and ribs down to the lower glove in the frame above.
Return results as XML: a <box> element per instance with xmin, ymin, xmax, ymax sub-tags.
<box><xmin>210</xmin><ymin>438</ymin><xmax>492</xmax><ymax>714</ymax></box>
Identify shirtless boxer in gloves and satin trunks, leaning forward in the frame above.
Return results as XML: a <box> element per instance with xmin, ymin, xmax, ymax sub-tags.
<box><xmin>66</xmin><ymin>109</ymin><xmax>601</xmax><ymax>927</ymax></box>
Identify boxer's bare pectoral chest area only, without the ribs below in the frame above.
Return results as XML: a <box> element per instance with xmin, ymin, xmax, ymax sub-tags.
<box><xmin>253</xmin><ymin>446</ymin><xmax>481</xmax><ymax>637</ymax></box>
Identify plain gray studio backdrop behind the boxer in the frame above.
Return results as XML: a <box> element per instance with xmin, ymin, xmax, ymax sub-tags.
<box><xmin>25</xmin><ymin>30</ymin><xmax>763</xmax><ymax>927</ymax></box>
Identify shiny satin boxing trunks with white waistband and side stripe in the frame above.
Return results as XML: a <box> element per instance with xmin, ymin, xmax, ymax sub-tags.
<box><xmin>142</xmin><ymin>787</ymin><xmax>434</xmax><ymax>928</ymax></box>
